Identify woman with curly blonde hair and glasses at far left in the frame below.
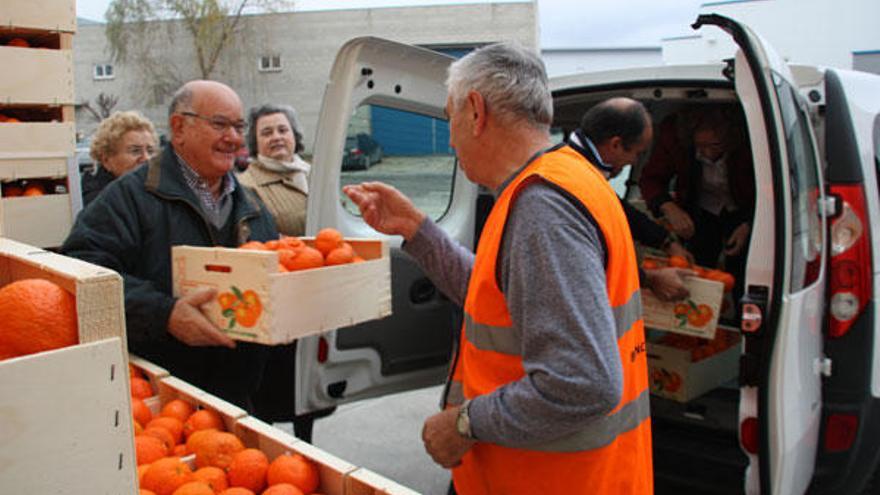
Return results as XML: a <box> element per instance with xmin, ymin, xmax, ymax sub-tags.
<box><xmin>82</xmin><ymin>111</ymin><xmax>158</xmax><ymax>207</ymax></box>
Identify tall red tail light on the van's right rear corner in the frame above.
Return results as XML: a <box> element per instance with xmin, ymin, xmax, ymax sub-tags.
<box><xmin>828</xmin><ymin>184</ymin><xmax>873</xmax><ymax>338</ymax></box>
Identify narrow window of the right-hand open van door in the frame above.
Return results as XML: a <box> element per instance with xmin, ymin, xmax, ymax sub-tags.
<box><xmin>774</xmin><ymin>76</ymin><xmax>824</xmax><ymax>292</ymax></box>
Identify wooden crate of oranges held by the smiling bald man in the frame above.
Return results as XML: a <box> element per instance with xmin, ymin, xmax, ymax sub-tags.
<box><xmin>172</xmin><ymin>229</ymin><xmax>391</xmax><ymax>344</ymax></box>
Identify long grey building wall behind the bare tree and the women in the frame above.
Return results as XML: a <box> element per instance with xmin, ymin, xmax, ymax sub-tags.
<box><xmin>74</xmin><ymin>2</ymin><xmax>538</xmax><ymax>152</ymax></box>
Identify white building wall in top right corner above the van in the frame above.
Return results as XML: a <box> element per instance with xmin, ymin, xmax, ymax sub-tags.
<box><xmin>663</xmin><ymin>0</ymin><xmax>880</xmax><ymax>69</ymax></box>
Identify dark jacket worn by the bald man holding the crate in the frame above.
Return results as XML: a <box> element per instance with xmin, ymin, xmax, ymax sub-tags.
<box><xmin>61</xmin><ymin>147</ymin><xmax>278</xmax><ymax>408</ymax></box>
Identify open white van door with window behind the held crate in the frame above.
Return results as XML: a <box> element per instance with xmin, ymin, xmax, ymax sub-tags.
<box><xmin>296</xmin><ymin>37</ymin><xmax>478</xmax><ymax>414</ymax></box>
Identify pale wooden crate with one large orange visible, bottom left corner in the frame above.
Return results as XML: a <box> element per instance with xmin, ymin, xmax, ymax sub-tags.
<box><xmin>0</xmin><ymin>239</ymin><xmax>136</xmax><ymax>494</ymax></box>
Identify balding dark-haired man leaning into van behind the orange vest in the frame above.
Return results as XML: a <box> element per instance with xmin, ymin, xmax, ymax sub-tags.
<box><xmin>568</xmin><ymin>97</ymin><xmax>694</xmax><ymax>301</ymax></box>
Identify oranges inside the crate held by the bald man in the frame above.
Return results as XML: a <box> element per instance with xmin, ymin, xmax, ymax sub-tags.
<box><xmin>239</xmin><ymin>228</ymin><xmax>364</xmax><ymax>272</ymax></box>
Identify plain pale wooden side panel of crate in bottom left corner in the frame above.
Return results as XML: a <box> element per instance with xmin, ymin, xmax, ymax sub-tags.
<box><xmin>0</xmin><ymin>338</ymin><xmax>137</xmax><ymax>495</ymax></box>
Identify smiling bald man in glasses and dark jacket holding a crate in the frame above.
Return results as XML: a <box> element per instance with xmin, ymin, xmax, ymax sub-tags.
<box><xmin>62</xmin><ymin>81</ymin><xmax>278</xmax><ymax>410</ymax></box>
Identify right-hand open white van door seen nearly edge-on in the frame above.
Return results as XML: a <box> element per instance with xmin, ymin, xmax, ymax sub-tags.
<box><xmin>694</xmin><ymin>15</ymin><xmax>827</xmax><ymax>494</ymax></box>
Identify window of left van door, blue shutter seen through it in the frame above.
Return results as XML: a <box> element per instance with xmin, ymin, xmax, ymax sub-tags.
<box><xmin>340</xmin><ymin>105</ymin><xmax>456</xmax><ymax>220</ymax></box>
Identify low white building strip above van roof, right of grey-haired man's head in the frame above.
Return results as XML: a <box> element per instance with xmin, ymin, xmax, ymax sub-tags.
<box><xmin>541</xmin><ymin>46</ymin><xmax>663</xmax><ymax>77</ymax></box>
